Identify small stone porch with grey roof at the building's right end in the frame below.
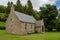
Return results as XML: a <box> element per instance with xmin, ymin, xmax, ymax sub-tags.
<box><xmin>35</xmin><ymin>19</ymin><xmax>45</xmax><ymax>33</ymax></box>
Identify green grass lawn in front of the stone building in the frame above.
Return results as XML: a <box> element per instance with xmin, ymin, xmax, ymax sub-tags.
<box><xmin>0</xmin><ymin>30</ymin><xmax>60</xmax><ymax>40</ymax></box>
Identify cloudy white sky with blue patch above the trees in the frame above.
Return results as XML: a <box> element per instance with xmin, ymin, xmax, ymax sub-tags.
<box><xmin>0</xmin><ymin>0</ymin><xmax>60</xmax><ymax>11</ymax></box>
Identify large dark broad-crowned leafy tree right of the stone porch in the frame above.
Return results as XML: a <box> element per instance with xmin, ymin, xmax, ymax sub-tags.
<box><xmin>40</xmin><ymin>4</ymin><xmax>58</xmax><ymax>31</ymax></box>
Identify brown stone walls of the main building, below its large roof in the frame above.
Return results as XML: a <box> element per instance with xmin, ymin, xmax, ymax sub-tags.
<box><xmin>6</xmin><ymin>12</ymin><xmax>35</xmax><ymax>34</ymax></box>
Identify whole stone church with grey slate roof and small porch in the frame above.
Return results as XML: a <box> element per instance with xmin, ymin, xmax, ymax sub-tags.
<box><xmin>6</xmin><ymin>6</ymin><xmax>45</xmax><ymax>34</ymax></box>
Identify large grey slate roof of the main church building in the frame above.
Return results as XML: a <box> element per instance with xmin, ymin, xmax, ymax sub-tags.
<box><xmin>15</xmin><ymin>11</ymin><xmax>36</xmax><ymax>23</ymax></box>
